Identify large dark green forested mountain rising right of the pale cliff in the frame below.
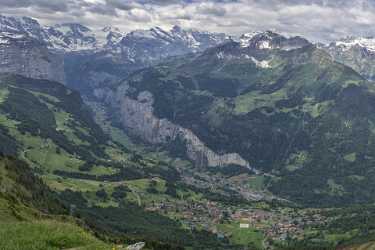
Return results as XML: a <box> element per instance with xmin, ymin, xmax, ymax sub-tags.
<box><xmin>123</xmin><ymin>42</ymin><xmax>375</xmax><ymax>206</ymax></box>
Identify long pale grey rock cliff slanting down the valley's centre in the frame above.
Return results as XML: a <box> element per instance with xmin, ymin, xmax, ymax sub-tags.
<box><xmin>117</xmin><ymin>87</ymin><xmax>254</xmax><ymax>171</ymax></box>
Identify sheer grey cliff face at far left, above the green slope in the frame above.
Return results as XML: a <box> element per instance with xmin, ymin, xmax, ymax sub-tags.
<box><xmin>0</xmin><ymin>34</ymin><xmax>65</xmax><ymax>83</ymax></box>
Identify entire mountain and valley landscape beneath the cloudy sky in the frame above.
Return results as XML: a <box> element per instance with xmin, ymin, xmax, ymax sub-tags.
<box><xmin>0</xmin><ymin>13</ymin><xmax>375</xmax><ymax>249</ymax></box>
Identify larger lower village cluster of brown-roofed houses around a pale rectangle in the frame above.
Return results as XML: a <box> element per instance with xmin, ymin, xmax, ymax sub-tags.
<box><xmin>146</xmin><ymin>193</ymin><xmax>327</xmax><ymax>244</ymax></box>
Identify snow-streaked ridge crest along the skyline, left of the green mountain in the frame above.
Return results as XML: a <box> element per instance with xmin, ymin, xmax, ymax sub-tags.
<box><xmin>0</xmin><ymin>16</ymin><xmax>226</xmax><ymax>52</ymax></box>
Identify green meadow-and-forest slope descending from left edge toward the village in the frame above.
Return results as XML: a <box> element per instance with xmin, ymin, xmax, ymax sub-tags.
<box><xmin>0</xmin><ymin>75</ymin><xmax>228</xmax><ymax>249</ymax></box>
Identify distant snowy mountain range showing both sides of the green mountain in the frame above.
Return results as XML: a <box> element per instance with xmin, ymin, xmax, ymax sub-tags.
<box><xmin>0</xmin><ymin>16</ymin><xmax>375</xmax><ymax>88</ymax></box>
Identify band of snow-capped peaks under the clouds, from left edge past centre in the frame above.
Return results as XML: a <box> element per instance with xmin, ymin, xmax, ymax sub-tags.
<box><xmin>0</xmin><ymin>15</ymin><xmax>227</xmax><ymax>56</ymax></box>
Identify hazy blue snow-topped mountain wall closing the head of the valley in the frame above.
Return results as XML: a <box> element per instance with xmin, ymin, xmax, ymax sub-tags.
<box><xmin>61</xmin><ymin>24</ymin><xmax>226</xmax><ymax>97</ymax></box>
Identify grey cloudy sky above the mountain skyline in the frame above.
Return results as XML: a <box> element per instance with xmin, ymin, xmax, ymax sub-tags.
<box><xmin>0</xmin><ymin>0</ymin><xmax>375</xmax><ymax>41</ymax></box>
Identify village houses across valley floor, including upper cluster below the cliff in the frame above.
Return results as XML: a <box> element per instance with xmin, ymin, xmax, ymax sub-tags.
<box><xmin>132</xmin><ymin>162</ymin><xmax>328</xmax><ymax>246</ymax></box>
